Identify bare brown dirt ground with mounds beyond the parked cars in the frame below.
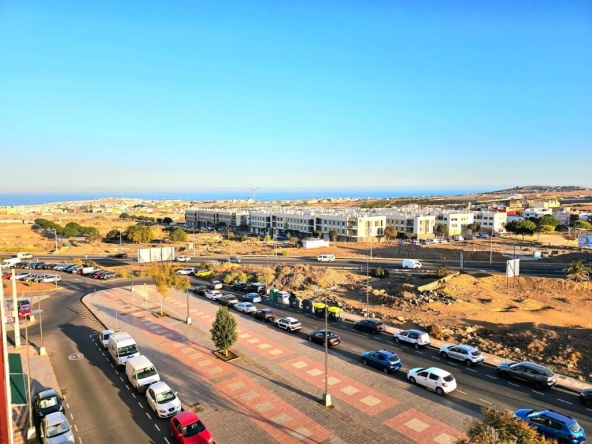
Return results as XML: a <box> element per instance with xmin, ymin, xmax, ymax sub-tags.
<box><xmin>0</xmin><ymin>215</ymin><xmax>592</xmax><ymax>381</ymax></box>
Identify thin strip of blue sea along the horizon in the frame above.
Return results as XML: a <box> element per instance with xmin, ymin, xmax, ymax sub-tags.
<box><xmin>0</xmin><ymin>189</ymin><xmax>482</xmax><ymax>207</ymax></box>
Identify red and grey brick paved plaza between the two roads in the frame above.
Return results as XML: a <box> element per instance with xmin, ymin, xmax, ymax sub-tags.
<box><xmin>84</xmin><ymin>287</ymin><xmax>469</xmax><ymax>444</ymax></box>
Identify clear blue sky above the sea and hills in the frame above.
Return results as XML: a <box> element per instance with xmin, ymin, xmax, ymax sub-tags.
<box><xmin>0</xmin><ymin>0</ymin><xmax>592</xmax><ymax>192</ymax></box>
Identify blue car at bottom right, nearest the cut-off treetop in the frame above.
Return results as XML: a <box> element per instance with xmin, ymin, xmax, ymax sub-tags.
<box><xmin>514</xmin><ymin>409</ymin><xmax>586</xmax><ymax>444</ymax></box>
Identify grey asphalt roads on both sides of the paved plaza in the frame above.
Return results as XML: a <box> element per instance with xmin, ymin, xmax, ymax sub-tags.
<box><xmin>16</xmin><ymin>273</ymin><xmax>592</xmax><ymax>444</ymax></box>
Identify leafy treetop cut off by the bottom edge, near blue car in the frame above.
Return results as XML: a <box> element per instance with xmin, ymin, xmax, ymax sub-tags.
<box><xmin>454</xmin><ymin>407</ymin><xmax>556</xmax><ymax>444</ymax></box>
